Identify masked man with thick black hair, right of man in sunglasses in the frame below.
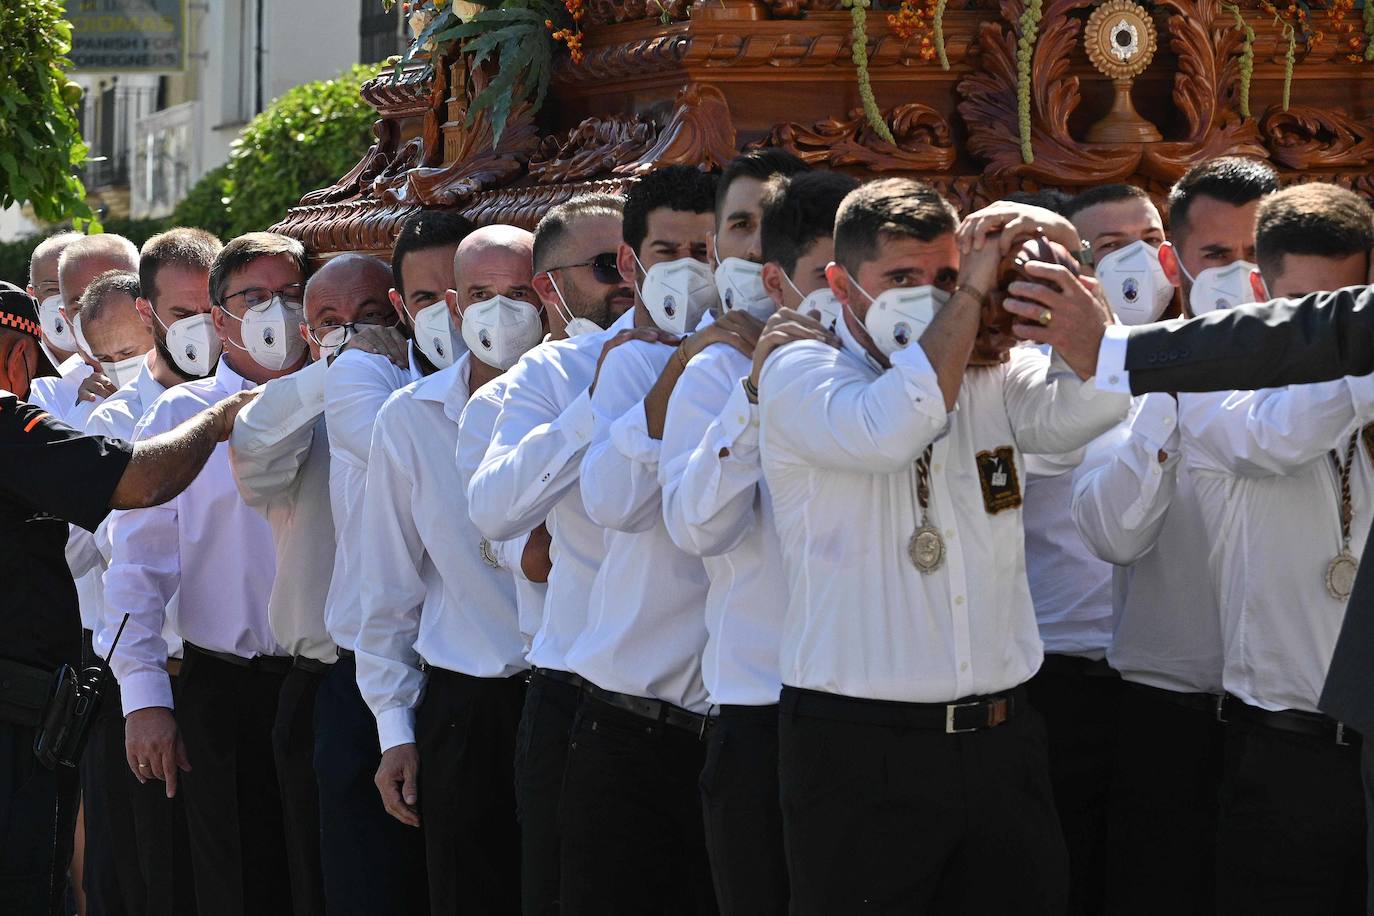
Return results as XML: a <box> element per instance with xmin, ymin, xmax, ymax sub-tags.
<box><xmin>555</xmin><ymin>166</ymin><xmax>758</xmax><ymax>913</ymax></box>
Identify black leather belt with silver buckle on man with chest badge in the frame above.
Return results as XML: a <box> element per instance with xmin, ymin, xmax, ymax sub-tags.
<box><xmin>780</xmin><ymin>687</ymin><xmax>1026</xmax><ymax>735</ymax></box>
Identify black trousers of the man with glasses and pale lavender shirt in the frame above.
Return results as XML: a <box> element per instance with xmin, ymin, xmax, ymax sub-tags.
<box><xmin>176</xmin><ymin>644</ymin><xmax>291</xmax><ymax>916</ymax></box>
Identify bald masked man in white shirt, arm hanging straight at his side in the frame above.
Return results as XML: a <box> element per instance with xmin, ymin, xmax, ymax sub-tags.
<box><xmin>356</xmin><ymin>225</ymin><xmax>544</xmax><ymax>916</ymax></box>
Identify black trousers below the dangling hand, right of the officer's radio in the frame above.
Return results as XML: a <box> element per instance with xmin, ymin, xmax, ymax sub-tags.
<box><xmin>81</xmin><ymin>678</ymin><xmax>195</xmax><ymax>916</ymax></box>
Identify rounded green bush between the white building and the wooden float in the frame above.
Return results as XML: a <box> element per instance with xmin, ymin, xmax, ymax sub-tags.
<box><xmin>214</xmin><ymin>65</ymin><xmax>379</xmax><ymax>239</ymax></box>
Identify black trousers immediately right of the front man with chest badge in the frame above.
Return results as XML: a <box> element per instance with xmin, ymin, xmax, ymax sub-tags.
<box><xmin>1026</xmin><ymin>655</ymin><xmax>1121</xmax><ymax>916</ymax></box>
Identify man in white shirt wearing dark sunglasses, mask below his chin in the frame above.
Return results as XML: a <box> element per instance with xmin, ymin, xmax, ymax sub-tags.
<box><xmin>469</xmin><ymin>199</ymin><xmax>635</xmax><ymax>915</ymax></box>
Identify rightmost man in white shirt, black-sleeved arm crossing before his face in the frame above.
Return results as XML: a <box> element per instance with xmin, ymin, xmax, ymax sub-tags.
<box><xmin>1179</xmin><ymin>184</ymin><xmax>1374</xmax><ymax>913</ymax></box>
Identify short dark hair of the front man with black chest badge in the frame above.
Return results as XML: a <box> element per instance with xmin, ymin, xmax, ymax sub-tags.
<box><xmin>835</xmin><ymin>179</ymin><xmax>959</xmax><ymax>273</ymax></box>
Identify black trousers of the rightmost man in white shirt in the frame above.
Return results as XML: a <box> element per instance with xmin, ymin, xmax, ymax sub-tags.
<box><xmin>1216</xmin><ymin>718</ymin><xmax>1366</xmax><ymax>916</ymax></box>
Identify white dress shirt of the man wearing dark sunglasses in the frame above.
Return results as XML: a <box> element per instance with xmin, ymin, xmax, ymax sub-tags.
<box><xmin>467</xmin><ymin>309</ymin><xmax>635</xmax><ymax>672</ymax></box>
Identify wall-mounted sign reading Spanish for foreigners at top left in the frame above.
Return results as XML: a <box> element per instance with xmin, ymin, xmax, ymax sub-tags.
<box><xmin>67</xmin><ymin>0</ymin><xmax>185</xmax><ymax>73</ymax></box>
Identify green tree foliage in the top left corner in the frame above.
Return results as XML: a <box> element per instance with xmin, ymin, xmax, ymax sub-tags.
<box><xmin>0</xmin><ymin>0</ymin><xmax>92</xmax><ymax>222</ymax></box>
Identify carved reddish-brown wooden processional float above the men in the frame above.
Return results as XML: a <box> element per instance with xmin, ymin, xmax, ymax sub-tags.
<box><xmin>273</xmin><ymin>0</ymin><xmax>1374</xmax><ymax>258</ymax></box>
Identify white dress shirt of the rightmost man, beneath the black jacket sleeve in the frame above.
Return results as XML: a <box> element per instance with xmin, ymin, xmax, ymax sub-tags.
<box><xmin>1179</xmin><ymin>376</ymin><xmax>1374</xmax><ymax>713</ymax></box>
